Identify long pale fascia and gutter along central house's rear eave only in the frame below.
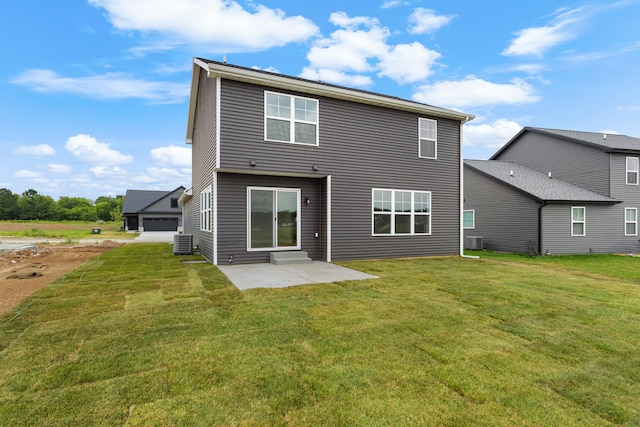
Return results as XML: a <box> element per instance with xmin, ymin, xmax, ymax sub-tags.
<box><xmin>205</xmin><ymin>59</ymin><xmax>475</xmax><ymax>123</ymax></box>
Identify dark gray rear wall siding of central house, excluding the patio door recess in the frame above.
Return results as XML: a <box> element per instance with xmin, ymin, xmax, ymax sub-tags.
<box><xmin>220</xmin><ymin>80</ymin><xmax>460</xmax><ymax>260</ymax></box>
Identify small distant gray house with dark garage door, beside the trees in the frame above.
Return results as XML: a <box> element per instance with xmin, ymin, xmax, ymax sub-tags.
<box><xmin>122</xmin><ymin>187</ymin><xmax>184</xmax><ymax>231</ymax></box>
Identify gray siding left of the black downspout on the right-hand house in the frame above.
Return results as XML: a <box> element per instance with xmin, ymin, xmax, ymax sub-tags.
<box><xmin>464</xmin><ymin>167</ymin><xmax>540</xmax><ymax>252</ymax></box>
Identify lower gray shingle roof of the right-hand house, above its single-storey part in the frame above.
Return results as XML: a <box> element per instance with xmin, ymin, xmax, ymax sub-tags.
<box><xmin>464</xmin><ymin>160</ymin><xmax>621</xmax><ymax>204</ymax></box>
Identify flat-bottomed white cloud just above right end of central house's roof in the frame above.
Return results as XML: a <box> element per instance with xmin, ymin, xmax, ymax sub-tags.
<box><xmin>413</xmin><ymin>76</ymin><xmax>540</xmax><ymax>108</ymax></box>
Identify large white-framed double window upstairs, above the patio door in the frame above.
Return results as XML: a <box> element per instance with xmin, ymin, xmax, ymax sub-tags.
<box><xmin>264</xmin><ymin>92</ymin><xmax>318</xmax><ymax>145</ymax></box>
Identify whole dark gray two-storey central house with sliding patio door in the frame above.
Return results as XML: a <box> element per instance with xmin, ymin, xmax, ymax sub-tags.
<box><xmin>181</xmin><ymin>58</ymin><xmax>473</xmax><ymax>265</ymax></box>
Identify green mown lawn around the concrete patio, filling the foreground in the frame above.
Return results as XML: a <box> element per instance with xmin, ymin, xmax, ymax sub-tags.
<box><xmin>0</xmin><ymin>245</ymin><xmax>640</xmax><ymax>426</ymax></box>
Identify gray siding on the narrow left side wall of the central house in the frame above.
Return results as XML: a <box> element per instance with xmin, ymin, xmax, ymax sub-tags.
<box><xmin>189</xmin><ymin>70</ymin><xmax>217</xmax><ymax>261</ymax></box>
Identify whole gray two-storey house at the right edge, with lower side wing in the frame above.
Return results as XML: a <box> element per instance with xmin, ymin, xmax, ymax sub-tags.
<box><xmin>463</xmin><ymin>127</ymin><xmax>640</xmax><ymax>254</ymax></box>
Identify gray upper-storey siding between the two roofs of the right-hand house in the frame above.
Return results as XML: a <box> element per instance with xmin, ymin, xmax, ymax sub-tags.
<box><xmin>493</xmin><ymin>132</ymin><xmax>610</xmax><ymax>196</ymax></box>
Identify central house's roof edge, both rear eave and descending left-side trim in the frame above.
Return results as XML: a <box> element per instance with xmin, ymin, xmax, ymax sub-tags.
<box><xmin>187</xmin><ymin>58</ymin><xmax>475</xmax><ymax>144</ymax></box>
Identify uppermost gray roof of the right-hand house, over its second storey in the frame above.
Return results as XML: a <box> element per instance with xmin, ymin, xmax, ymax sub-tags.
<box><xmin>491</xmin><ymin>126</ymin><xmax>640</xmax><ymax>159</ymax></box>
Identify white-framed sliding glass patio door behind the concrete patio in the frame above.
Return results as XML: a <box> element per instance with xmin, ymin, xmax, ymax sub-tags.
<box><xmin>247</xmin><ymin>187</ymin><xmax>300</xmax><ymax>250</ymax></box>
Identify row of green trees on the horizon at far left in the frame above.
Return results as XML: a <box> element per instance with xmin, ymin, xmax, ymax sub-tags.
<box><xmin>0</xmin><ymin>188</ymin><xmax>124</xmax><ymax>222</ymax></box>
